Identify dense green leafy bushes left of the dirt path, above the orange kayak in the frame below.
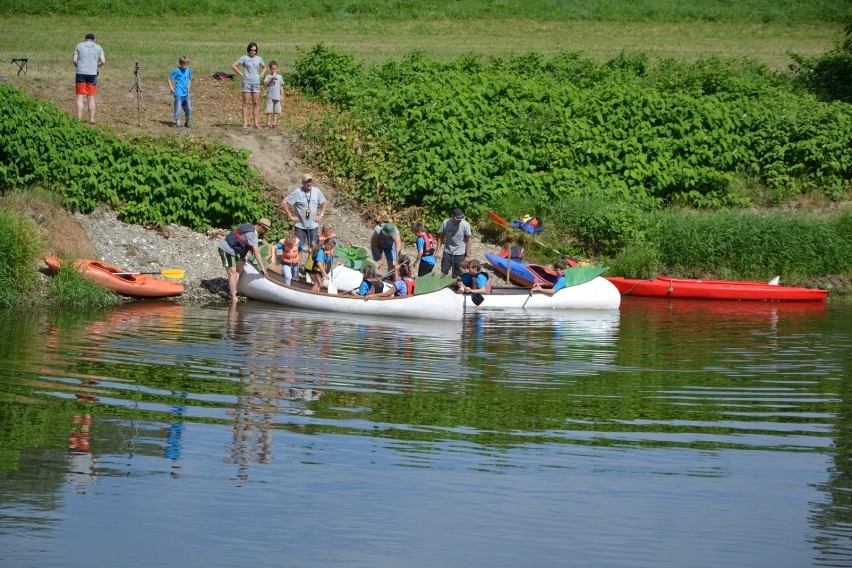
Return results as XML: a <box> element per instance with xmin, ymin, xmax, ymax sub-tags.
<box><xmin>0</xmin><ymin>85</ymin><xmax>271</xmax><ymax>230</ymax></box>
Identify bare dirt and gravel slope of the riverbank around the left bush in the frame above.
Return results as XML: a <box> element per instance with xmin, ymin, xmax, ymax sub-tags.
<box><xmin>29</xmin><ymin>80</ymin><xmax>494</xmax><ymax>301</ymax></box>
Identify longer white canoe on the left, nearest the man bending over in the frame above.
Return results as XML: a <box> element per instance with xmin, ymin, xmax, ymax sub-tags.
<box><xmin>237</xmin><ymin>264</ymin><xmax>464</xmax><ymax>321</ymax></box>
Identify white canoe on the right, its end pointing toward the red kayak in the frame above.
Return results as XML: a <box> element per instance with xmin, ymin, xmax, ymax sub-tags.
<box><xmin>459</xmin><ymin>276</ymin><xmax>621</xmax><ymax>311</ymax></box>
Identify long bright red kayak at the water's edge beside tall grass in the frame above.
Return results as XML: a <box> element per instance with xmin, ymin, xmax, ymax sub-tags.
<box><xmin>606</xmin><ymin>276</ymin><xmax>828</xmax><ymax>302</ymax></box>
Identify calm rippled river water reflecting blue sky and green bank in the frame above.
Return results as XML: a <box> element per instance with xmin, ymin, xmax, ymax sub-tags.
<box><xmin>0</xmin><ymin>298</ymin><xmax>852</xmax><ymax>568</ymax></box>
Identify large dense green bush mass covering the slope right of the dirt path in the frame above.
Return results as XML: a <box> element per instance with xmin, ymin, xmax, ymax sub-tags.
<box><xmin>293</xmin><ymin>48</ymin><xmax>852</xmax><ymax>220</ymax></box>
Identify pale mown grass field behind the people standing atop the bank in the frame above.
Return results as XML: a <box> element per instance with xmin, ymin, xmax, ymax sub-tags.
<box><xmin>0</xmin><ymin>15</ymin><xmax>842</xmax><ymax>85</ymax></box>
